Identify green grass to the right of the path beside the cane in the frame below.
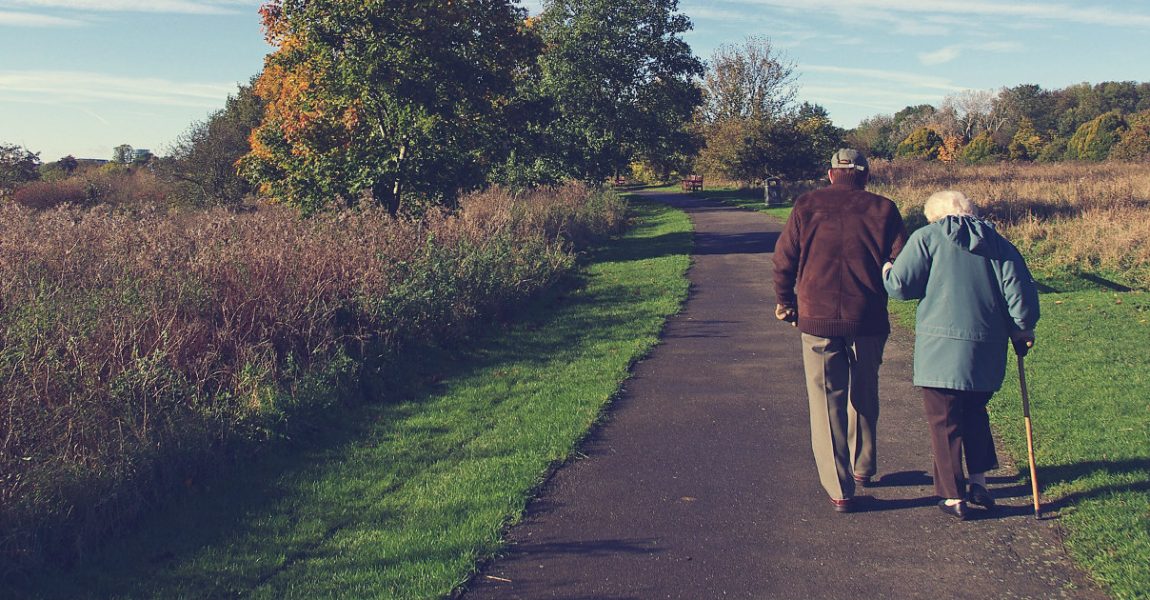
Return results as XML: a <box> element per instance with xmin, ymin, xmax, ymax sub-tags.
<box><xmin>891</xmin><ymin>286</ymin><xmax>1150</xmax><ymax>599</ymax></box>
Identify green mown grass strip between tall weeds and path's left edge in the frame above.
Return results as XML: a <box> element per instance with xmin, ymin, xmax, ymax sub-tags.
<box><xmin>13</xmin><ymin>197</ymin><xmax>691</xmax><ymax>599</ymax></box>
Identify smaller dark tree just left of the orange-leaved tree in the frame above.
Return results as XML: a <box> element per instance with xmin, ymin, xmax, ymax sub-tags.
<box><xmin>159</xmin><ymin>78</ymin><xmax>263</xmax><ymax>206</ymax></box>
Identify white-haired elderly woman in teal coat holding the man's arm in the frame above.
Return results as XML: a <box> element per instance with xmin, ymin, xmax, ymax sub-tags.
<box><xmin>883</xmin><ymin>191</ymin><xmax>1038</xmax><ymax>518</ymax></box>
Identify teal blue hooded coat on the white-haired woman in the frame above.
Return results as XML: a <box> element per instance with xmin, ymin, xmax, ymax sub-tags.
<box><xmin>883</xmin><ymin>216</ymin><xmax>1038</xmax><ymax>392</ymax></box>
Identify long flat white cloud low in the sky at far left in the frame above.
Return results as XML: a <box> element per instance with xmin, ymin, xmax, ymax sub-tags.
<box><xmin>0</xmin><ymin>71</ymin><xmax>236</xmax><ymax>108</ymax></box>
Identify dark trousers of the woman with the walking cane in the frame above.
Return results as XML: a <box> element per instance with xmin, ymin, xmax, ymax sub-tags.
<box><xmin>922</xmin><ymin>387</ymin><xmax>998</xmax><ymax>498</ymax></box>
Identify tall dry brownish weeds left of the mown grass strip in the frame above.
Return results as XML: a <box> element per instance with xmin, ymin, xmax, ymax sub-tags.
<box><xmin>0</xmin><ymin>181</ymin><xmax>623</xmax><ymax>568</ymax></box>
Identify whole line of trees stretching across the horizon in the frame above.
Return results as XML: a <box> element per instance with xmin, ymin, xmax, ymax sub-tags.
<box><xmin>0</xmin><ymin>0</ymin><xmax>1150</xmax><ymax>213</ymax></box>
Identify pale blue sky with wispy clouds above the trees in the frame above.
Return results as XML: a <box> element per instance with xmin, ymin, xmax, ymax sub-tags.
<box><xmin>0</xmin><ymin>0</ymin><xmax>1150</xmax><ymax>162</ymax></box>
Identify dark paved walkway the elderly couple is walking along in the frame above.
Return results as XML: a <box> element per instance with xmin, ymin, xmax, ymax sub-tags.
<box><xmin>465</xmin><ymin>194</ymin><xmax>1104</xmax><ymax>600</ymax></box>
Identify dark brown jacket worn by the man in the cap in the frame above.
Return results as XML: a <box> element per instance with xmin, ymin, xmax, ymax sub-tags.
<box><xmin>774</xmin><ymin>184</ymin><xmax>906</xmax><ymax>338</ymax></box>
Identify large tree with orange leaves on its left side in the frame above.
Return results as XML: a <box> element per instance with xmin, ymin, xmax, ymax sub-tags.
<box><xmin>240</xmin><ymin>0</ymin><xmax>538</xmax><ymax>214</ymax></box>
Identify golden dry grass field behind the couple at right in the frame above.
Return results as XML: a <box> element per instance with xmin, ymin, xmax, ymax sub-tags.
<box><xmin>871</xmin><ymin>161</ymin><xmax>1150</xmax><ymax>290</ymax></box>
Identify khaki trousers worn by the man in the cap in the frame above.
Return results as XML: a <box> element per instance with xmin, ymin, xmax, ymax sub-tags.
<box><xmin>803</xmin><ymin>333</ymin><xmax>887</xmax><ymax>499</ymax></box>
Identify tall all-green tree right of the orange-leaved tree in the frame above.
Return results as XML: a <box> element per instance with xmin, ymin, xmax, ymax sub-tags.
<box><xmin>536</xmin><ymin>0</ymin><xmax>703</xmax><ymax>182</ymax></box>
